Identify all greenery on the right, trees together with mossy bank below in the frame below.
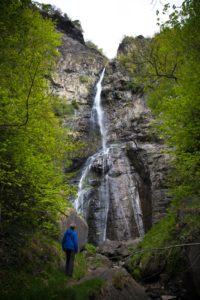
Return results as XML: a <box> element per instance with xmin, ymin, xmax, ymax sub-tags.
<box><xmin>119</xmin><ymin>0</ymin><xmax>200</xmax><ymax>280</ymax></box>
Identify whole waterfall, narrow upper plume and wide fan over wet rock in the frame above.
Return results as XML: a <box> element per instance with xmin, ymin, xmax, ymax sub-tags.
<box><xmin>74</xmin><ymin>69</ymin><xmax>144</xmax><ymax>244</ymax></box>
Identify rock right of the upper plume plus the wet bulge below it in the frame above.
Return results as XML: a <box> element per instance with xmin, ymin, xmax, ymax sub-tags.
<box><xmin>75</xmin><ymin>63</ymin><xmax>170</xmax><ymax>244</ymax></box>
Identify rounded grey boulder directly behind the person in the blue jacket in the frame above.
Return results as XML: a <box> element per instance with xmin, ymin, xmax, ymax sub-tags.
<box><xmin>60</xmin><ymin>209</ymin><xmax>88</xmax><ymax>250</ymax></box>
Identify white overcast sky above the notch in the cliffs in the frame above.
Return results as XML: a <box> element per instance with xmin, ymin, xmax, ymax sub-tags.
<box><xmin>36</xmin><ymin>0</ymin><xmax>183</xmax><ymax>58</ymax></box>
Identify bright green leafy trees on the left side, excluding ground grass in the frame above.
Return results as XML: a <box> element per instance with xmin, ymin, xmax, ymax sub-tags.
<box><xmin>0</xmin><ymin>0</ymin><xmax>74</xmax><ymax>264</ymax></box>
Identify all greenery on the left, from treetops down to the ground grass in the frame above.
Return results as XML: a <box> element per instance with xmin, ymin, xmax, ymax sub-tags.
<box><xmin>0</xmin><ymin>0</ymin><xmax>105</xmax><ymax>300</ymax></box>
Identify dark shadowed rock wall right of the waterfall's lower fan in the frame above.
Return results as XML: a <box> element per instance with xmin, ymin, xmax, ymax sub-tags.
<box><xmin>127</xmin><ymin>142</ymin><xmax>170</xmax><ymax>224</ymax></box>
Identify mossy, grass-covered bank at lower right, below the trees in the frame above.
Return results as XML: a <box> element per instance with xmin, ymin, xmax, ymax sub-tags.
<box><xmin>129</xmin><ymin>199</ymin><xmax>200</xmax><ymax>281</ymax></box>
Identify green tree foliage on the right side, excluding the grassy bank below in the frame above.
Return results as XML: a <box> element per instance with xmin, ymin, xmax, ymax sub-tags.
<box><xmin>120</xmin><ymin>0</ymin><xmax>200</xmax><ymax>209</ymax></box>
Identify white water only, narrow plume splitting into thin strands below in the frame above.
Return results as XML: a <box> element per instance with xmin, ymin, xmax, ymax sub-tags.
<box><xmin>74</xmin><ymin>69</ymin><xmax>144</xmax><ymax>241</ymax></box>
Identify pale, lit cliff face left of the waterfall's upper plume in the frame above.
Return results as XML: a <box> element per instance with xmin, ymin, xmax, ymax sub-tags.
<box><xmin>51</xmin><ymin>29</ymin><xmax>107</xmax><ymax>138</ymax></box>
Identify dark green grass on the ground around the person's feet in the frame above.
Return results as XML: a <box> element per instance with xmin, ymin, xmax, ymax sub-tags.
<box><xmin>0</xmin><ymin>253</ymin><xmax>103</xmax><ymax>300</ymax></box>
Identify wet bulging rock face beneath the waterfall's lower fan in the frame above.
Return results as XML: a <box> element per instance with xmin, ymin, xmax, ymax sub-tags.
<box><xmin>81</xmin><ymin>145</ymin><xmax>148</xmax><ymax>244</ymax></box>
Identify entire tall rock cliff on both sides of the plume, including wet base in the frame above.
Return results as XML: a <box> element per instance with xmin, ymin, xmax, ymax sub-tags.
<box><xmin>52</xmin><ymin>19</ymin><xmax>170</xmax><ymax>244</ymax></box>
